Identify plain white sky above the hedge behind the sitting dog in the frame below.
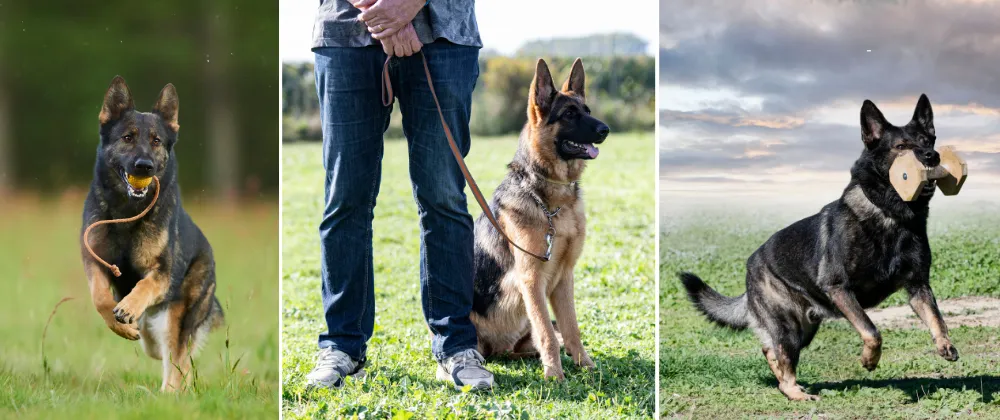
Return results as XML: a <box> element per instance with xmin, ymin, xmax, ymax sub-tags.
<box><xmin>279</xmin><ymin>0</ymin><xmax>657</xmax><ymax>62</ymax></box>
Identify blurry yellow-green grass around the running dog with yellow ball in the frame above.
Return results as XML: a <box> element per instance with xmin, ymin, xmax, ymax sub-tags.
<box><xmin>0</xmin><ymin>193</ymin><xmax>279</xmax><ymax>419</ymax></box>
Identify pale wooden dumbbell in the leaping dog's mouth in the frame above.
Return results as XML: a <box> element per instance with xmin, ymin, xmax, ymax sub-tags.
<box><xmin>889</xmin><ymin>146</ymin><xmax>969</xmax><ymax>201</ymax></box>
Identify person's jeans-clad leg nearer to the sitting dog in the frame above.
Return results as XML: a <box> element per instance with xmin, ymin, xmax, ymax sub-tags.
<box><xmin>396</xmin><ymin>41</ymin><xmax>479</xmax><ymax>361</ymax></box>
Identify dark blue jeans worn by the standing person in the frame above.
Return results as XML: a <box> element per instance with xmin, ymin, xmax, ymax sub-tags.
<box><xmin>314</xmin><ymin>41</ymin><xmax>479</xmax><ymax>360</ymax></box>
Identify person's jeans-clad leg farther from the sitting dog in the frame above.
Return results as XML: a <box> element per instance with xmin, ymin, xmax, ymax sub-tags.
<box><xmin>315</xmin><ymin>47</ymin><xmax>391</xmax><ymax>360</ymax></box>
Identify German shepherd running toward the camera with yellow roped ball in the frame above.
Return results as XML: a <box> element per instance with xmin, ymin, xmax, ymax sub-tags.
<box><xmin>80</xmin><ymin>76</ymin><xmax>223</xmax><ymax>392</ymax></box>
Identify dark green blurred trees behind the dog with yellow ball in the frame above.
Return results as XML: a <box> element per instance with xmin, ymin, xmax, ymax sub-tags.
<box><xmin>0</xmin><ymin>0</ymin><xmax>279</xmax><ymax>199</ymax></box>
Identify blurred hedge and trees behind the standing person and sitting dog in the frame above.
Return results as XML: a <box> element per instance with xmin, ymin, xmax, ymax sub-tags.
<box><xmin>281</xmin><ymin>33</ymin><xmax>656</xmax><ymax>141</ymax></box>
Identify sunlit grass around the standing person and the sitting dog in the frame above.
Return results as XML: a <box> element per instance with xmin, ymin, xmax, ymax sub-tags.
<box><xmin>282</xmin><ymin>133</ymin><xmax>656</xmax><ymax>418</ymax></box>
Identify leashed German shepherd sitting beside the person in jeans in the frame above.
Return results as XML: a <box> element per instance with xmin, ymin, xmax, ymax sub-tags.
<box><xmin>472</xmin><ymin>59</ymin><xmax>610</xmax><ymax>380</ymax></box>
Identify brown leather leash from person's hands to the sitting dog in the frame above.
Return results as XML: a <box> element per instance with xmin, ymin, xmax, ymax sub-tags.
<box><xmin>382</xmin><ymin>51</ymin><xmax>559</xmax><ymax>261</ymax></box>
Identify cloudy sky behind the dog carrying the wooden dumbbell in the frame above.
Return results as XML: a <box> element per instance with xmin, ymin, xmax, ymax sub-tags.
<box><xmin>658</xmin><ymin>0</ymin><xmax>1000</xmax><ymax>200</ymax></box>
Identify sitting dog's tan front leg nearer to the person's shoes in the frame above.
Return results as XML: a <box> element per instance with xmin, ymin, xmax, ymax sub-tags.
<box><xmin>517</xmin><ymin>266</ymin><xmax>566</xmax><ymax>381</ymax></box>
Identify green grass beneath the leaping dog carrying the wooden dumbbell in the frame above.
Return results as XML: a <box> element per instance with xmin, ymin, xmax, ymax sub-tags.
<box><xmin>659</xmin><ymin>202</ymin><xmax>1000</xmax><ymax>419</ymax></box>
